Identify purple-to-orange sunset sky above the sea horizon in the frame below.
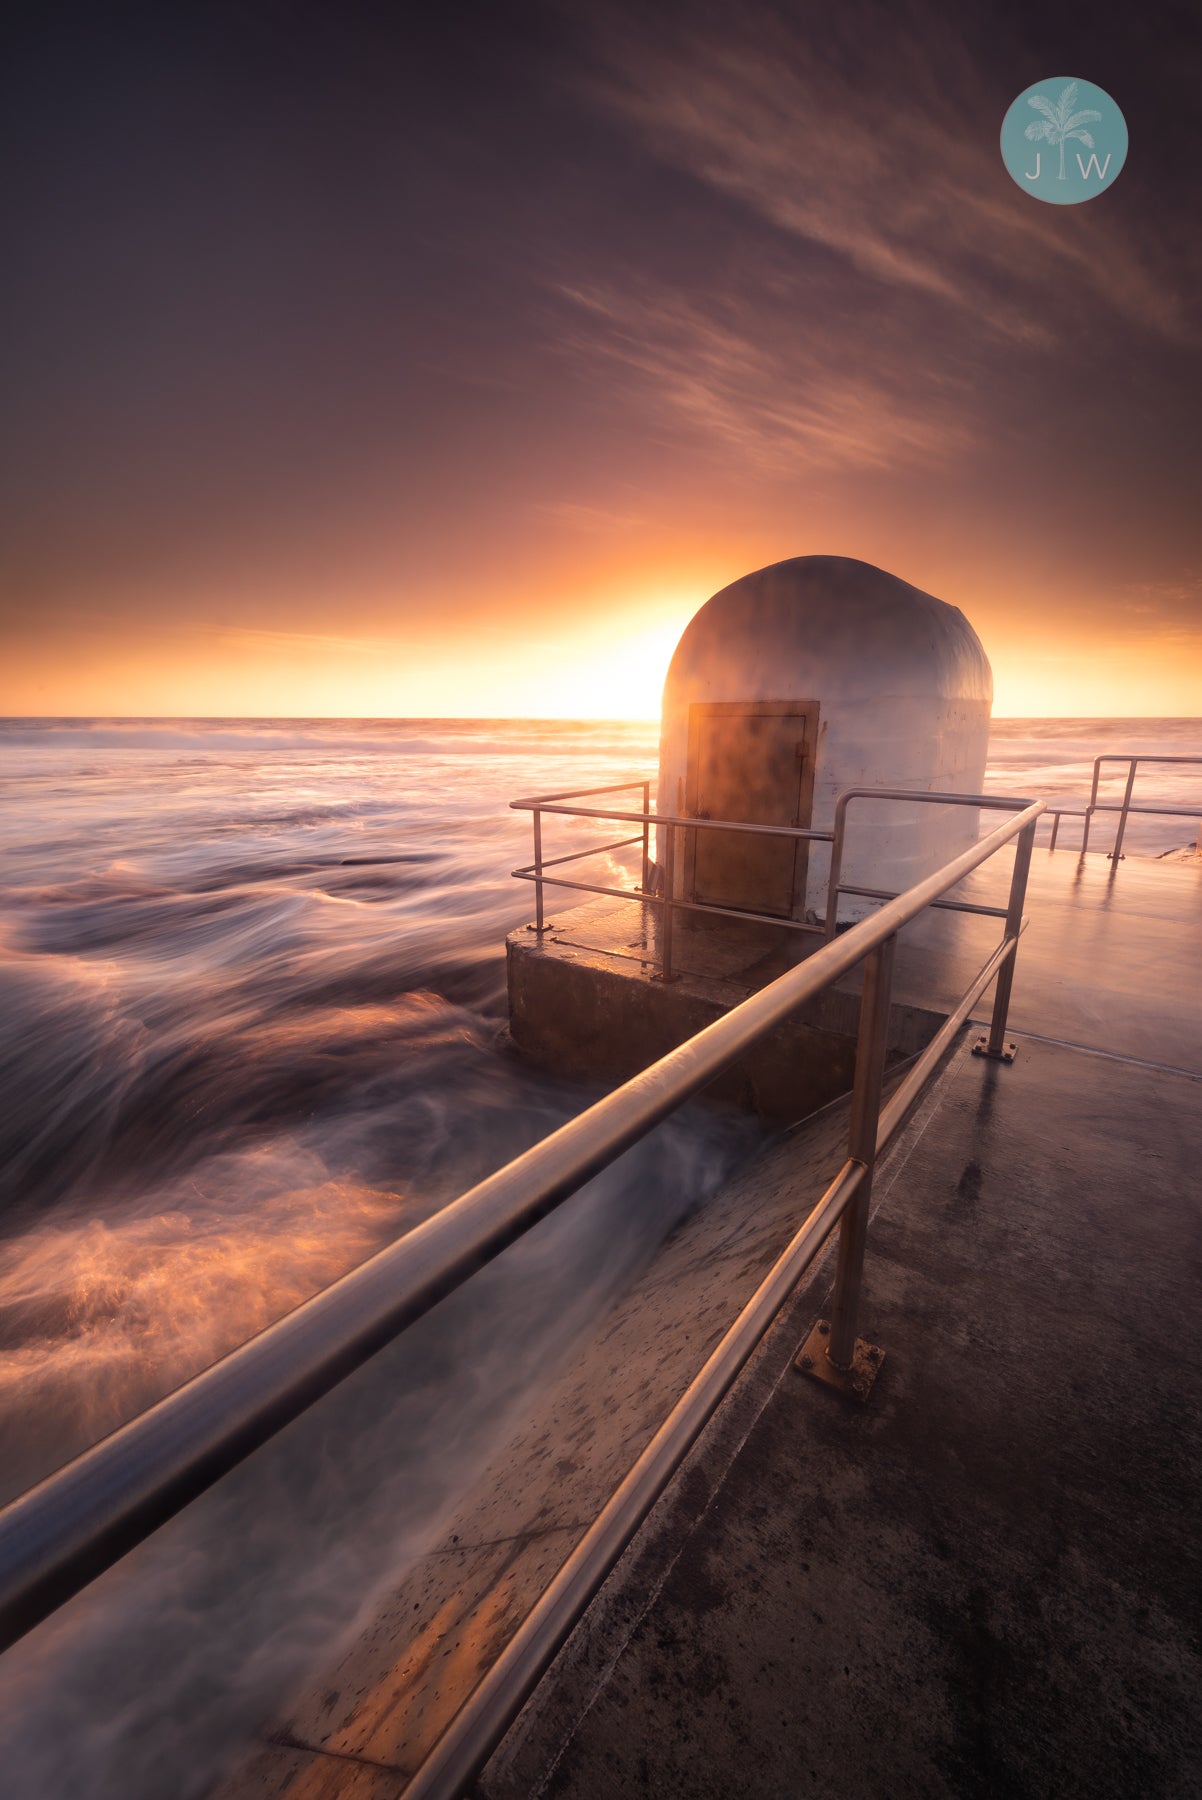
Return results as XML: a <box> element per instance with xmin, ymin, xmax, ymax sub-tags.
<box><xmin>0</xmin><ymin>0</ymin><xmax>1202</xmax><ymax>716</ymax></box>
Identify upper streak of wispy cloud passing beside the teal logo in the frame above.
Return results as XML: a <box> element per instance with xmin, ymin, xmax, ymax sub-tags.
<box><xmin>575</xmin><ymin>0</ymin><xmax>1197</xmax><ymax>346</ymax></box>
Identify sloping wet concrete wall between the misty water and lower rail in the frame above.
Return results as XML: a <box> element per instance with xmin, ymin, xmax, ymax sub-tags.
<box><xmin>212</xmin><ymin>1080</ymin><xmax>863</xmax><ymax>1800</ymax></box>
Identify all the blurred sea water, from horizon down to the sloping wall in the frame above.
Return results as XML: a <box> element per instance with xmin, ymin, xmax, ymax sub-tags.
<box><xmin>0</xmin><ymin>720</ymin><xmax>1202</xmax><ymax>1800</ymax></box>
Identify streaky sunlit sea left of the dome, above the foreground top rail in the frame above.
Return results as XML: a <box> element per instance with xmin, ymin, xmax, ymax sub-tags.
<box><xmin>0</xmin><ymin>722</ymin><xmax>676</xmax><ymax>1498</ymax></box>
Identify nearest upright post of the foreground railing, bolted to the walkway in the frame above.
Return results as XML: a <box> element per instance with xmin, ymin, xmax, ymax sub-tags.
<box><xmin>826</xmin><ymin>938</ymin><xmax>898</xmax><ymax>1373</ymax></box>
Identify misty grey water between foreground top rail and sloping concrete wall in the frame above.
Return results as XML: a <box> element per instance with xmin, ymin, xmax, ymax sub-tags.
<box><xmin>0</xmin><ymin>1102</ymin><xmax>749</xmax><ymax>1800</ymax></box>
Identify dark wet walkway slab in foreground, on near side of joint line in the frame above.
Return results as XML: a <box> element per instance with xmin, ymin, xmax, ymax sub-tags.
<box><xmin>480</xmin><ymin>1036</ymin><xmax>1202</xmax><ymax>1800</ymax></box>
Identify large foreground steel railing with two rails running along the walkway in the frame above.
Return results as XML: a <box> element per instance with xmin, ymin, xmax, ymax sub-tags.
<box><xmin>0</xmin><ymin>801</ymin><xmax>1044</xmax><ymax>1800</ymax></box>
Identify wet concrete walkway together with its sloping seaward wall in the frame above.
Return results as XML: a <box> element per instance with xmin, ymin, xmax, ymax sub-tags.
<box><xmin>211</xmin><ymin>851</ymin><xmax>1202</xmax><ymax>1800</ymax></box>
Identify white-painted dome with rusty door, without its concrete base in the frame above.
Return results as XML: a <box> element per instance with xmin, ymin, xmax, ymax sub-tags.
<box><xmin>659</xmin><ymin>556</ymin><xmax>993</xmax><ymax>918</ymax></box>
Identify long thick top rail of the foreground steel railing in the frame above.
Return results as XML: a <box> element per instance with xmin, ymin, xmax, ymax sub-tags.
<box><xmin>0</xmin><ymin>801</ymin><xmax>1044</xmax><ymax>1670</ymax></box>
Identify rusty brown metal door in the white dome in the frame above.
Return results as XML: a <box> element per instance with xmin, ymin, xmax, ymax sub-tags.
<box><xmin>686</xmin><ymin>700</ymin><xmax>819</xmax><ymax>918</ymax></box>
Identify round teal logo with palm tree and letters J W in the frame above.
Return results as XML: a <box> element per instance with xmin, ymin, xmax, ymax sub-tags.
<box><xmin>1002</xmin><ymin>76</ymin><xmax>1126</xmax><ymax>207</ymax></box>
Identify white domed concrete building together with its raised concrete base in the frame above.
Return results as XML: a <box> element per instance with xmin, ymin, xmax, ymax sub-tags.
<box><xmin>507</xmin><ymin>556</ymin><xmax>993</xmax><ymax>1120</ymax></box>
